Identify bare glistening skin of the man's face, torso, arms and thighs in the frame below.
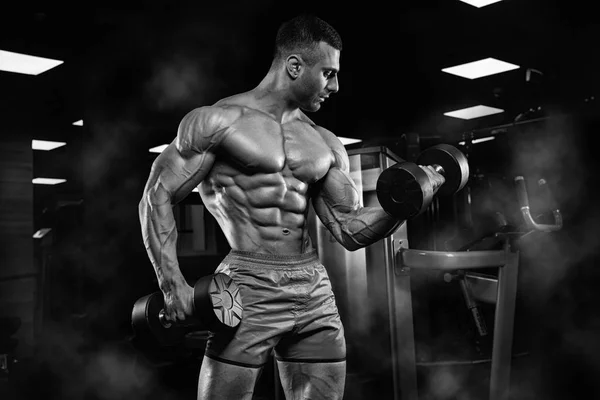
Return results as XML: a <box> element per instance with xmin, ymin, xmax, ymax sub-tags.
<box><xmin>139</xmin><ymin>38</ymin><xmax>443</xmax><ymax>400</ymax></box>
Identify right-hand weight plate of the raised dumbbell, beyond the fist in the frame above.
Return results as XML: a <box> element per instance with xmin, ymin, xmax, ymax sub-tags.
<box><xmin>416</xmin><ymin>144</ymin><xmax>469</xmax><ymax>196</ymax></box>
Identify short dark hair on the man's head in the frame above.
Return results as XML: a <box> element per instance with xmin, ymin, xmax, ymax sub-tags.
<box><xmin>273</xmin><ymin>14</ymin><xmax>342</xmax><ymax>65</ymax></box>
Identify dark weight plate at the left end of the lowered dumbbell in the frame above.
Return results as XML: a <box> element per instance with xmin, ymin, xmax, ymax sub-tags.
<box><xmin>131</xmin><ymin>291</ymin><xmax>186</xmax><ymax>346</ymax></box>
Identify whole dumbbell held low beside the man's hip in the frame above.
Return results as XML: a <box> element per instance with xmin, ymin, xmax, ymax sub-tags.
<box><xmin>131</xmin><ymin>273</ymin><xmax>243</xmax><ymax>346</ymax></box>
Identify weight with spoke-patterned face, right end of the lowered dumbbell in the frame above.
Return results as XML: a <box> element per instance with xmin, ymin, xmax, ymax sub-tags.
<box><xmin>194</xmin><ymin>273</ymin><xmax>243</xmax><ymax>330</ymax></box>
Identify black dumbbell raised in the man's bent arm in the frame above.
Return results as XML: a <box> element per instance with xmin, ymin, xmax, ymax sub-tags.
<box><xmin>376</xmin><ymin>144</ymin><xmax>469</xmax><ymax>219</ymax></box>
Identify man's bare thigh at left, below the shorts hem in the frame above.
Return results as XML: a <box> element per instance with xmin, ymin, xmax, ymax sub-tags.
<box><xmin>198</xmin><ymin>357</ymin><xmax>261</xmax><ymax>400</ymax></box>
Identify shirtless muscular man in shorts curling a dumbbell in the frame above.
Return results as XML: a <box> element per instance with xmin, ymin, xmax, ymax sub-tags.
<box><xmin>139</xmin><ymin>16</ymin><xmax>443</xmax><ymax>400</ymax></box>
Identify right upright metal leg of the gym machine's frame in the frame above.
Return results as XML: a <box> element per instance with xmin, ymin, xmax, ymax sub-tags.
<box><xmin>490</xmin><ymin>244</ymin><xmax>519</xmax><ymax>400</ymax></box>
